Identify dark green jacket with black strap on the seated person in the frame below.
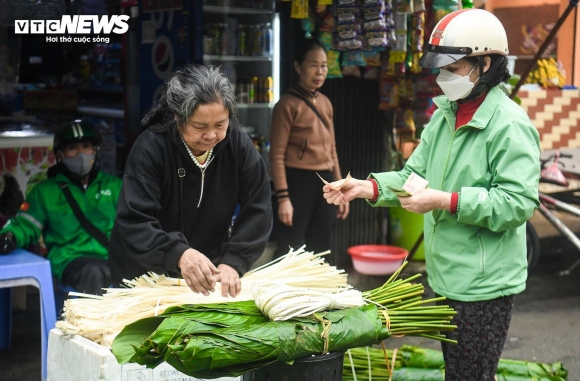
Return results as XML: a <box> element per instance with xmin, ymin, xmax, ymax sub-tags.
<box><xmin>0</xmin><ymin>166</ymin><xmax>122</xmax><ymax>280</ymax></box>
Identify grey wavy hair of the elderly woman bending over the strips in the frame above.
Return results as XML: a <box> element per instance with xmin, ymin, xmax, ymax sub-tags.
<box><xmin>141</xmin><ymin>65</ymin><xmax>236</xmax><ymax>132</ymax></box>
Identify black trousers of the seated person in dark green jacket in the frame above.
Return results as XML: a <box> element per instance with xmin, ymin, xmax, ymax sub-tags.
<box><xmin>62</xmin><ymin>257</ymin><xmax>111</xmax><ymax>295</ymax></box>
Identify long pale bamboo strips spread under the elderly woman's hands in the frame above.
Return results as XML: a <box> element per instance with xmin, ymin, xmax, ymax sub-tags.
<box><xmin>56</xmin><ymin>247</ymin><xmax>351</xmax><ymax>347</ymax></box>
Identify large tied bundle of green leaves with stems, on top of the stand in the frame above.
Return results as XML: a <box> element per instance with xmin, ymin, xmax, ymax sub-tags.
<box><xmin>112</xmin><ymin>263</ymin><xmax>455</xmax><ymax>378</ymax></box>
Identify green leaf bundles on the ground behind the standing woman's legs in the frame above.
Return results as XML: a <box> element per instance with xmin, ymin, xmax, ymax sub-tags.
<box><xmin>342</xmin><ymin>345</ymin><xmax>568</xmax><ymax>381</ymax></box>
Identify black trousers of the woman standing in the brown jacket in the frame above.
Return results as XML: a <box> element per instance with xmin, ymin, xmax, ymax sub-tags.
<box><xmin>274</xmin><ymin>168</ymin><xmax>336</xmax><ymax>258</ymax></box>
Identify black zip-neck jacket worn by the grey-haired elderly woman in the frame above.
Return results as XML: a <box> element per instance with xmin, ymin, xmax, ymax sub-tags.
<box><xmin>109</xmin><ymin>123</ymin><xmax>272</xmax><ymax>285</ymax></box>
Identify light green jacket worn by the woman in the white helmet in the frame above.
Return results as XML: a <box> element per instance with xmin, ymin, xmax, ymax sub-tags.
<box><xmin>370</xmin><ymin>86</ymin><xmax>540</xmax><ymax>301</ymax></box>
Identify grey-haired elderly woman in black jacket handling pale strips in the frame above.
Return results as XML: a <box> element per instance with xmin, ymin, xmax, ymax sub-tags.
<box><xmin>109</xmin><ymin>65</ymin><xmax>272</xmax><ymax>296</ymax></box>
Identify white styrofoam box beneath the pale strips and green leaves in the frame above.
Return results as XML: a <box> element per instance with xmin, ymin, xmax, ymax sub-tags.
<box><xmin>47</xmin><ymin>328</ymin><xmax>242</xmax><ymax>381</ymax></box>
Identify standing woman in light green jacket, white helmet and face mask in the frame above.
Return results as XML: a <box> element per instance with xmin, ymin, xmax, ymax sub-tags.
<box><xmin>324</xmin><ymin>9</ymin><xmax>540</xmax><ymax>381</ymax></box>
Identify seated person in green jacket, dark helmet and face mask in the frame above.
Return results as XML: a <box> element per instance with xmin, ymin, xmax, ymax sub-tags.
<box><xmin>0</xmin><ymin>120</ymin><xmax>121</xmax><ymax>295</ymax></box>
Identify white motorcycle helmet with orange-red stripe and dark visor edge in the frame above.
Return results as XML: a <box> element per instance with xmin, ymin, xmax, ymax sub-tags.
<box><xmin>419</xmin><ymin>9</ymin><xmax>509</xmax><ymax>69</ymax></box>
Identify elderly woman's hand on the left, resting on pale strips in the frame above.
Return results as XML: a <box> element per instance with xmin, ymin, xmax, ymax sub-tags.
<box><xmin>177</xmin><ymin>249</ymin><xmax>220</xmax><ymax>296</ymax></box>
